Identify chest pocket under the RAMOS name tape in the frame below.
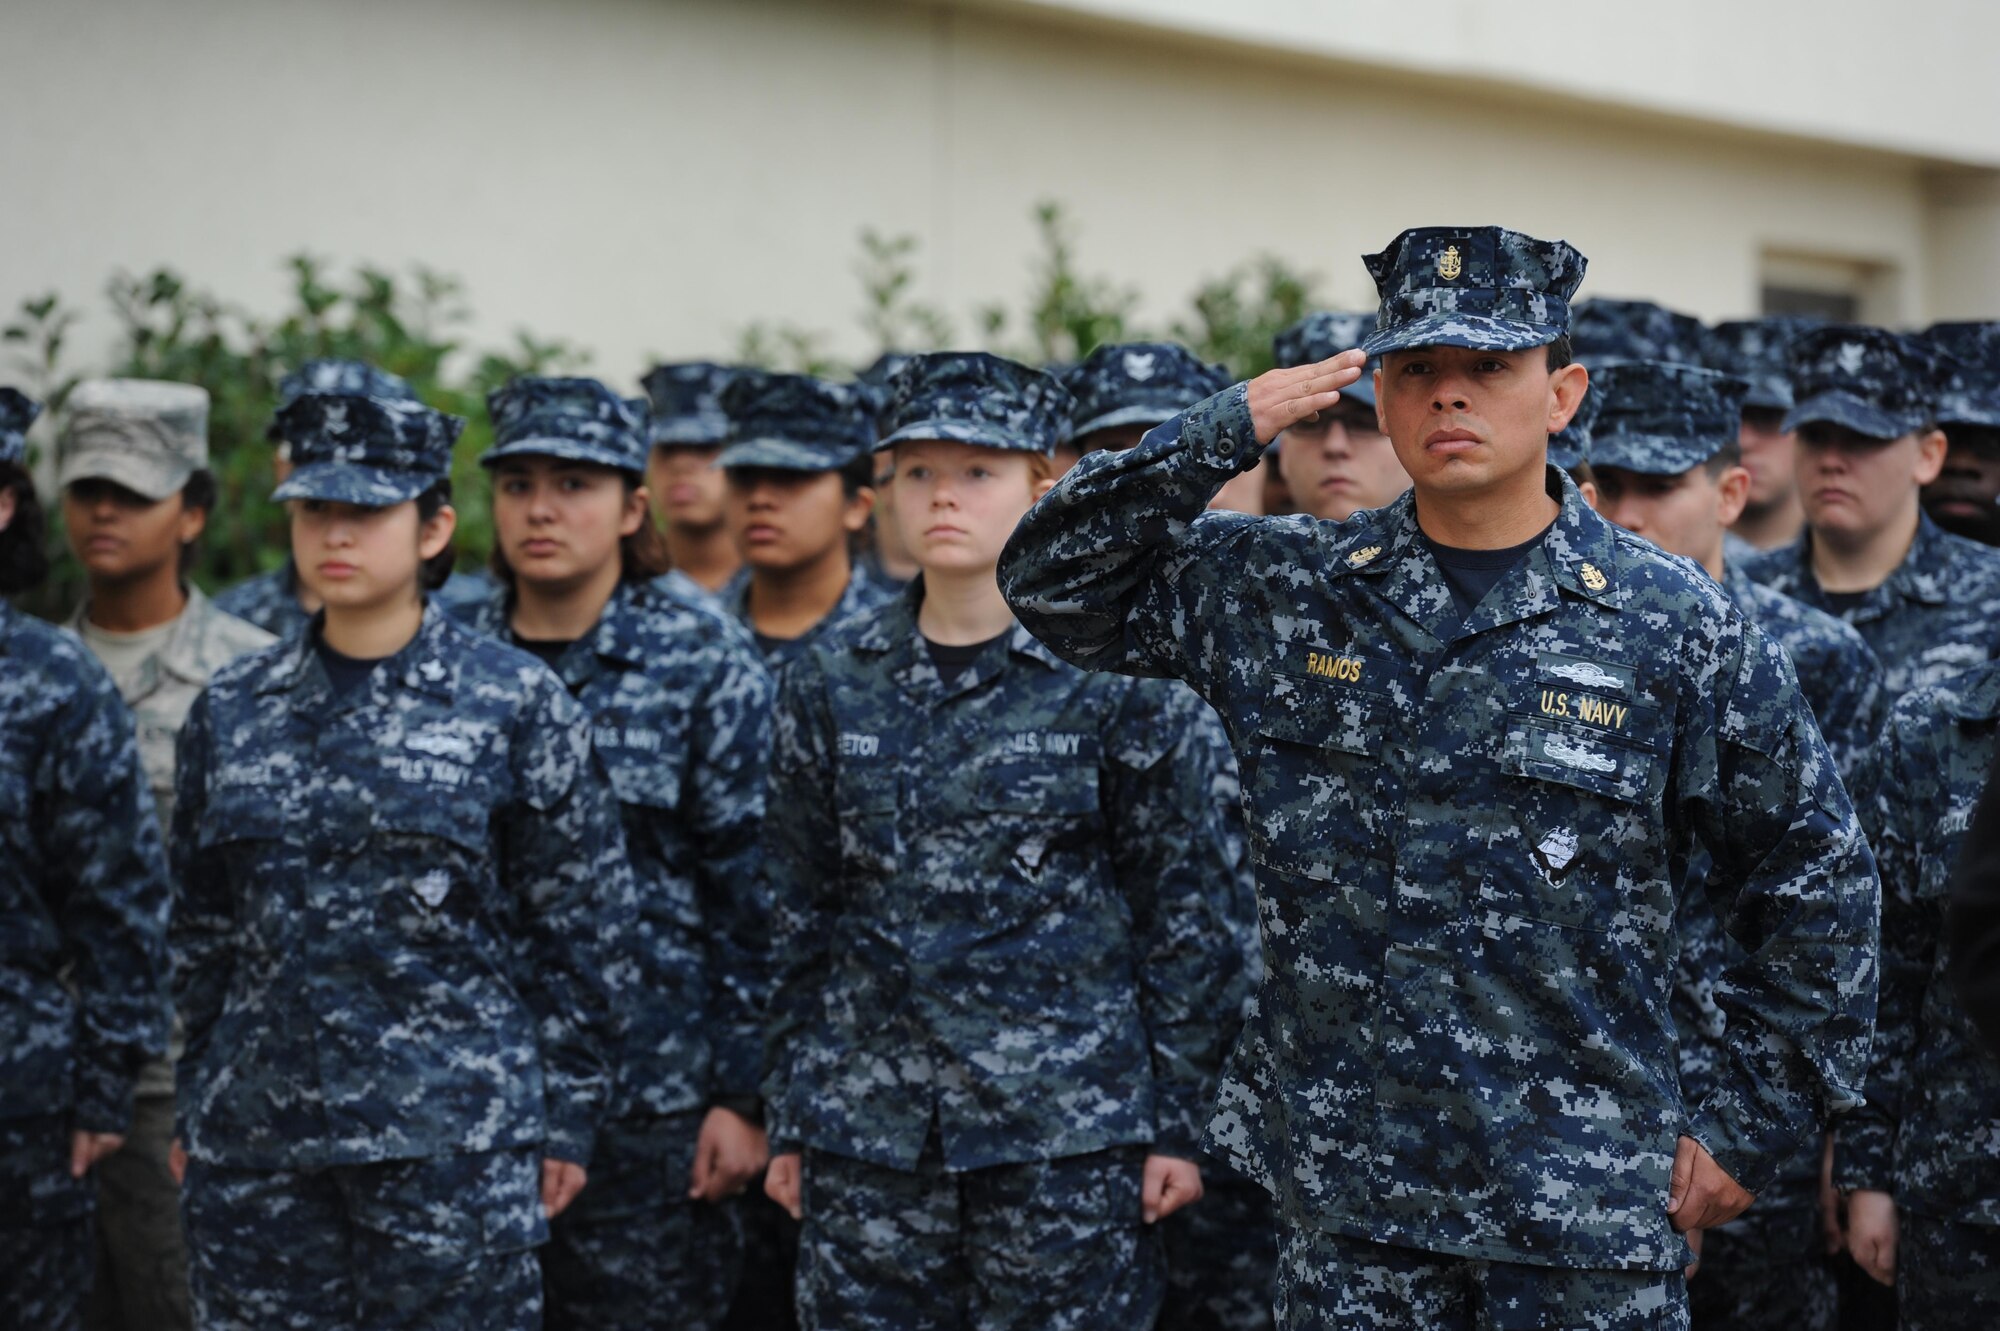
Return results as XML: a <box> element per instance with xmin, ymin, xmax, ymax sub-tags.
<box><xmin>1242</xmin><ymin>658</ymin><xmax>1396</xmax><ymax>881</ymax></box>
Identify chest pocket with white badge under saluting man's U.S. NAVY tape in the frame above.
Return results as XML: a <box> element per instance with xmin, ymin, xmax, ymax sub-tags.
<box><xmin>1480</xmin><ymin>715</ymin><xmax>1674</xmax><ymax>933</ymax></box>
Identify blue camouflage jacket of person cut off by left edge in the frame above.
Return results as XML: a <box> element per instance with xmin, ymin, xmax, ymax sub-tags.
<box><xmin>0</xmin><ymin>600</ymin><xmax>168</xmax><ymax>1133</ymax></box>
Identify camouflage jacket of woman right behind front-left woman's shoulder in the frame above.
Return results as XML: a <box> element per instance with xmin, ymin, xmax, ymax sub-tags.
<box><xmin>458</xmin><ymin>580</ymin><xmax>774</xmax><ymax>1117</ymax></box>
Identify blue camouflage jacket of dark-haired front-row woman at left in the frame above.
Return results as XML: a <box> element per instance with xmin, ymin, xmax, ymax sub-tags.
<box><xmin>172</xmin><ymin>604</ymin><xmax>630</xmax><ymax>1169</ymax></box>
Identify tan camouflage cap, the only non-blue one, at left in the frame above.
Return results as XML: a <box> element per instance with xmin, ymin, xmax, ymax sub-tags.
<box><xmin>56</xmin><ymin>380</ymin><xmax>208</xmax><ymax>502</ymax></box>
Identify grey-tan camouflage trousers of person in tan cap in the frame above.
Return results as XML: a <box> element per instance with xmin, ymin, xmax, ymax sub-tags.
<box><xmin>84</xmin><ymin>1095</ymin><xmax>194</xmax><ymax>1331</ymax></box>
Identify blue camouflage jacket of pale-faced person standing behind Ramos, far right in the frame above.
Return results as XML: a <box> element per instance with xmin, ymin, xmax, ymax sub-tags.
<box><xmin>1742</xmin><ymin>512</ymin><xmax>2000</xmax><ymax>695</ymax></box>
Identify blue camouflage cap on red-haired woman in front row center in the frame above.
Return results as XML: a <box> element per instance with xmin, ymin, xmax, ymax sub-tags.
<box><xmin>876</xmin><ymin>352</ymin><xmax>1074</xmax><ymax>458</ymax></box>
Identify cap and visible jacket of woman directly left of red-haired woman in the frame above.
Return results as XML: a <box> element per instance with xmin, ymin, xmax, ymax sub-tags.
<box><xmin>716</xmin><ymin>370</ymin><xmax>896</xmax><ymax>671</ymax></box>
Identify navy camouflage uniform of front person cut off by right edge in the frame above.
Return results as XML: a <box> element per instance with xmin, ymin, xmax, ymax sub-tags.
<box><xmin>1834</xmin><ymin>664</ymin><xmax>2000</xmax><ymax>1331</ymax></box>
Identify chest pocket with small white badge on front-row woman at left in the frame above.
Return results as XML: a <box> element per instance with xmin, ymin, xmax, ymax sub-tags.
<box><xmin>370</xmin><ymin>799</ymin><xmax>492</xmax><ymax>939</ymax></box>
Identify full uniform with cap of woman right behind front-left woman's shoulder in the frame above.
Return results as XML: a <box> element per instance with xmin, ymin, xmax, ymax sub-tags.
<box><xmin>460</xmin><ymin>378</ymin><xmax>772</xmax><ymax>1331</ymax></box>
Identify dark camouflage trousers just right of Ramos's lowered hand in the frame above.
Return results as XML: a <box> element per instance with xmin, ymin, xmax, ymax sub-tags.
<box><xmin>1688</xmin><ymin>1205</ymin><xmax>1840</xmax><ymax>1331</ymax></box>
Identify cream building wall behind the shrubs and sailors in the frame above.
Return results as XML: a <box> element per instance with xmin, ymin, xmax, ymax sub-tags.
<box><xmin>0</xmin><ymin>0</ymin><xmax>2000</xmax><ymax>388</ymax></box>
